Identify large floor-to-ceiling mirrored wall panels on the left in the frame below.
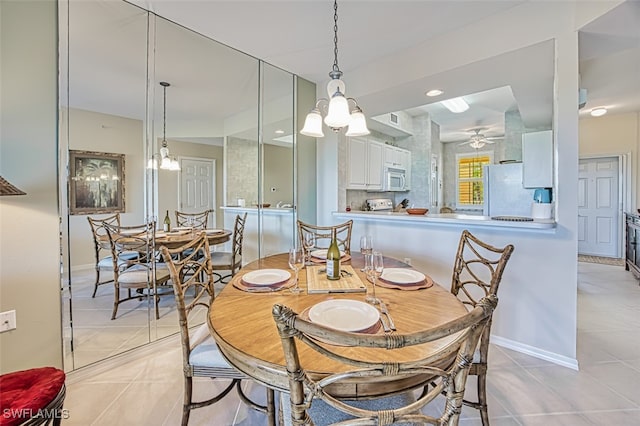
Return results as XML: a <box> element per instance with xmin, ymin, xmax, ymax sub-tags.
<box><xmin>60</xmin><ymin>0</ymin><xmax>304</xmax><ymax>370</ymax></box>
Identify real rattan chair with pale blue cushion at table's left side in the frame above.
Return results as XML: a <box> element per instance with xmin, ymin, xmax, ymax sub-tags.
<box><xmin>160</xmin><ymin>232</ymin><xmax>275</xmax><ymax>426</ymax></box>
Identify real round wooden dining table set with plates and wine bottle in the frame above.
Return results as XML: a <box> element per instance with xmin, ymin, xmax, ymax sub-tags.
<box><xmin>208</xmin><ymin>253</ymin><xmax>467</xmax><ymax>412</ymax></box>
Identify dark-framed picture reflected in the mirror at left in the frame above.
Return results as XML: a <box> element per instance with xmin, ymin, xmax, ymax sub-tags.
<box><xmin>69</xmin><ymin>150</ymin><xmax>125</xmax><ymax>214</ymax></box>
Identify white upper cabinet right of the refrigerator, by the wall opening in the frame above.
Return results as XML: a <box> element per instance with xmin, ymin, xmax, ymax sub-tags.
<box><xmin>522</xmin><ymin>130</ymin><xmax>553</xmax><ymax>188</ymax></box>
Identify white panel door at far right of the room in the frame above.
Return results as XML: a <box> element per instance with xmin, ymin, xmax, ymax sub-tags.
<box><xmin>578</xmin><ymin>158</ymin><xmax>620</xmax><ymax>258</ymax></box>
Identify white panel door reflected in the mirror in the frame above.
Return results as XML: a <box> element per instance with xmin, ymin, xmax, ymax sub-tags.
<box><xmin>179</xmin><ymin>158</ymin><xmax>216</xmax><ymax>228</ymax></box>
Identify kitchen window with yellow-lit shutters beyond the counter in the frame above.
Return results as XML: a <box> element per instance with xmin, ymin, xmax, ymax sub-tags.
<box><xmin>457</xmin><ymin>153</ymin><xmax>492</xmax><ymax>208</ymax></box>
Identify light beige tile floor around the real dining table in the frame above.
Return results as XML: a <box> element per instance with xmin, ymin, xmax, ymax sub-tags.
<box><xmin>64</xmin><ymin>263</ymin><xmax>640</xmax><ymax>426</ymax></box>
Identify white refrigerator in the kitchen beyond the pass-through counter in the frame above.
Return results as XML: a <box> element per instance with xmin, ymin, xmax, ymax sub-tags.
<box><xmin>483</xmin><ymin>163</ymin><xmax>535</xmax><ymax>217</ymax></box>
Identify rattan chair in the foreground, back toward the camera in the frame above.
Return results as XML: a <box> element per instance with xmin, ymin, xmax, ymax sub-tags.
<box><xmin>272</xmin><ymin>295</ymin><xmax>497</xmax><ymax>425</ymax></box>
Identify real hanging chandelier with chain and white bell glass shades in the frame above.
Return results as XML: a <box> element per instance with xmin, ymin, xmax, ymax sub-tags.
<box><xmin>300</xmin><ymin>0</ymin><xmax>370</xmax><ymax>138</ymax></box>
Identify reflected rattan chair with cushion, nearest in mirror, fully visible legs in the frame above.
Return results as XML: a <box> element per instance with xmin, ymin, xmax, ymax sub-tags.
<box><xmin>105</xmin><ymin>221</ymin><xmax>169</xmax><ymax>320</ymax></box>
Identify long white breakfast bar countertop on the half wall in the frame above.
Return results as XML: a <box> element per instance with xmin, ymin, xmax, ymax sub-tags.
<box><xmin>332</xmin><ymin>210</ymin><xmax>556</xmax><ymax>230</ymax></box>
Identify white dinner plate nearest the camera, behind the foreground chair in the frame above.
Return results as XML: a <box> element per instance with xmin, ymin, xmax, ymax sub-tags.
<box><xmin>309</xmin><ymin>299</ymin><xmax>380</xmax><ymax>332</ymax></box>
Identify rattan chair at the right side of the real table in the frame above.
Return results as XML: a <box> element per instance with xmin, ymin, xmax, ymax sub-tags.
<box><xmin>451</xmin><ymin>229</ymin><xmax>514</xmax><ymax>426</ymax></box>
